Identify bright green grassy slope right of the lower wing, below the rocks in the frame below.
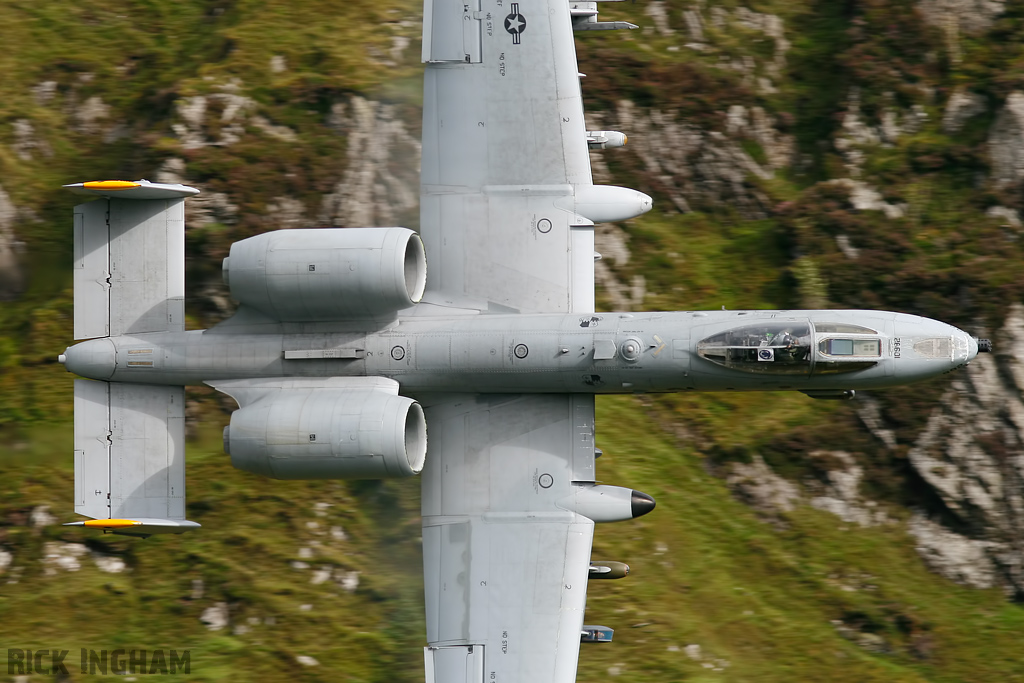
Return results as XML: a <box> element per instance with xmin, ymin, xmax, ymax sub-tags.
<box><xmin>580</xmin><ymin>397</ymin><xmax>1024</xmax><ymax>682</ymax></box>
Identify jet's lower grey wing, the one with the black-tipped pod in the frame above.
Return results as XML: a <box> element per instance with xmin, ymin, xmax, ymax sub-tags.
<box><xmin>422</xmin><ymin>394</ymin><xmax>594</xmax><ymax>683</ymax></box>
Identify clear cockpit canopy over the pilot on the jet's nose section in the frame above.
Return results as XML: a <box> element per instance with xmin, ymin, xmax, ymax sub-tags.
<box><xmin>697</xmin><ymin>321</ymin><xmax>882</xmax><ymax>377</ymax></box>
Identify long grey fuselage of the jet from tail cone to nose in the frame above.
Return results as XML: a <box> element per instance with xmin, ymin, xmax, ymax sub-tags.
<box><xmin>63</xmin><ymin>310</ymin><xmax>978</xmax><ymax>395</ymax></box>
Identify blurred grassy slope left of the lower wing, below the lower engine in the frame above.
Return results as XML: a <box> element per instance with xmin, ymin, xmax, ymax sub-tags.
<box><xmin>0</xmin><ymin>424</ymin><xmax>424</xmax><ymax>683</ymax></box>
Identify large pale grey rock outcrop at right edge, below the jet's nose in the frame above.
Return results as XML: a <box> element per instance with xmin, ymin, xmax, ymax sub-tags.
<box><xmin>908</xmin><ymin>304</ymin><xmax>1024</xmax><ymax>596</ymax></box>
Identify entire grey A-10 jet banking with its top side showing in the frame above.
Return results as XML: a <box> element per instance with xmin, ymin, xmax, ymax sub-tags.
<box><xmin>60</xmin><ymin>0</ymin><xmax>987</xmax><ymax>683</ymax></box>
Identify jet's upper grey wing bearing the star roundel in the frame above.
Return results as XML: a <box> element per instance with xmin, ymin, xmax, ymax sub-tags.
<box><xmin>420</xmin><ymin>0</ymin><xmax>594</xmax><ymax>312</ymax></box>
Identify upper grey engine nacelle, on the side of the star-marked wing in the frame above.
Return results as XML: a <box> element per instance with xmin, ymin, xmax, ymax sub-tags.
<box><xmin>223</xmin><ymin>227</ymin><xmax>427</xmax><ymax>323</ymax></box>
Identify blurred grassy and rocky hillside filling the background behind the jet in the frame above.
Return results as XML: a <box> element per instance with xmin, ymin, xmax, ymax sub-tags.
<box><xmin>6</xmin><ymin>0</ymin><xmax>1024</xmax><ymax>681</ymax></box>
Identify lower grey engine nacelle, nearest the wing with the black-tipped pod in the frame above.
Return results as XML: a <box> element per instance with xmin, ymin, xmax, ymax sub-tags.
<box><xmin>215</xmin><ymin>378</ymin><xmax>427</xmax><ymax>479</ymax></box>
